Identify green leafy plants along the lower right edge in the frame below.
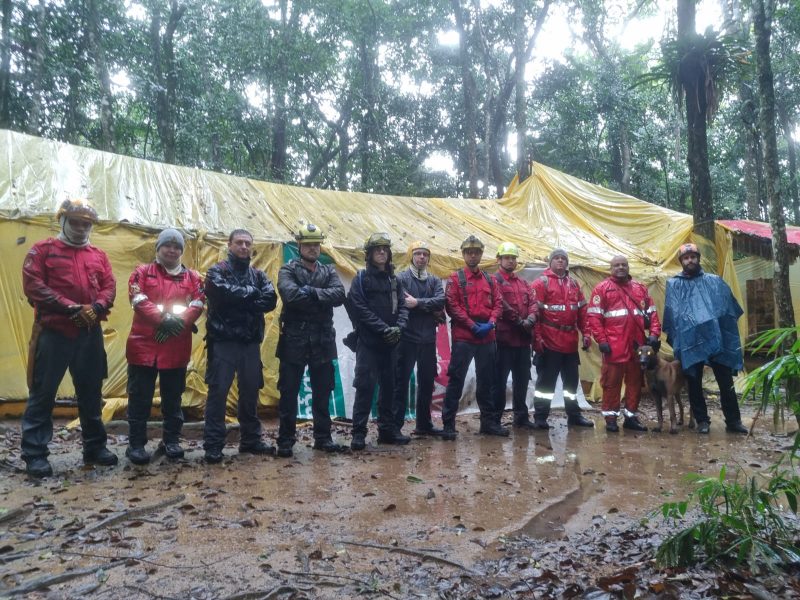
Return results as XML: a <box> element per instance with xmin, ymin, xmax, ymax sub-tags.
<box><xmin>656</xmin><ymin>327</ymin><xmax>800</xmax><ymax>571</ymax></box>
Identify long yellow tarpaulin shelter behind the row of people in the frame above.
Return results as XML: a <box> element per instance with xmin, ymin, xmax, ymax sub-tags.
<box><xmin>0</xmin><ymin>131</ymin><xmax>712</xmax><ymax>418</ymax></box>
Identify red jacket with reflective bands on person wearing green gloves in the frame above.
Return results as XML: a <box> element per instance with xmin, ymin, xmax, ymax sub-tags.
<box><xmin>125</xmin><ymin>262</ymin><xmax>206</xmax><ymax>369</ymax></box>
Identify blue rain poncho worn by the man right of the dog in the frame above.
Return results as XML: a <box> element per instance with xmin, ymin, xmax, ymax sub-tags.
<box><xmin>663</xmin><ymin>270</ymin><xmax>743</xmax><ymax>371</ymax></box>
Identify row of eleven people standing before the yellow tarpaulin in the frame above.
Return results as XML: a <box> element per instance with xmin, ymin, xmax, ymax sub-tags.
<box><xmin>22</xmin><ymin>200</ymin><xmax>746</xmax><ymax>477</ymax></box>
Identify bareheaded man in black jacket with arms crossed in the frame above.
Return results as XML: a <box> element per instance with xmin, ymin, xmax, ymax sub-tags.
<box><xmin>203</xmin><ymin>229</ymin><xmax>278</xmax><ymax>463</ymax></box>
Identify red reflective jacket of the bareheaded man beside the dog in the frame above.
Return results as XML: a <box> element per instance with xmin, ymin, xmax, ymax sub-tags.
<box><xmin>587</xmin><ymin>277</ymin><xmax>661</xmax><ymax>363</ymax></box>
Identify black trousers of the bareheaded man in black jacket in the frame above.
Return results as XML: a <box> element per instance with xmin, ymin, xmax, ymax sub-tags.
<box><xmin>203</xmin><ymin>341</ymin><xmax>264</xmax><ymax>450</ymax></box>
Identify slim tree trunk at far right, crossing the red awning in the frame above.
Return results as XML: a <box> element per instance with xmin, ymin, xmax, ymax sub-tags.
<box><xmin>752</xmin><ymin>0</ymin><xmax>794</xmax><ymax>327</ymax></box>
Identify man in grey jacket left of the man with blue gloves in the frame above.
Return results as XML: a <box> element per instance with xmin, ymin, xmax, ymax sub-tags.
<box><xmin>395</xmin><ymin>241</ymin><xmax>444</xmax><ymax>436</ymax></box>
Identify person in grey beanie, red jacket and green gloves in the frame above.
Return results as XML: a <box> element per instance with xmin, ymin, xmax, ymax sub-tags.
<box><xmin>125</xmin><ymin>228</ymin><xmax>205</xmax><ymax>465</ymax></box>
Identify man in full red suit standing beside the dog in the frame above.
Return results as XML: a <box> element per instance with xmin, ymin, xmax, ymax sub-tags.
<box><xmin>587</xmin><ymin>256</ymin><xmax>661</xmax><ymax>432</ymax></box>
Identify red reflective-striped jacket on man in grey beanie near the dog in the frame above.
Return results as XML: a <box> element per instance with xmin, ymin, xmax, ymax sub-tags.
<box><xmin>531</xmin><ymin>269</ymin><xmax>589</xmax><ymax>353</ymax></box>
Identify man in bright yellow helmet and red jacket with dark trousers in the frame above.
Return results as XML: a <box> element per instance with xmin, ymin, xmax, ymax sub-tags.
<box><xmin>495</xmin><ymin>242</ymin><xmax>536</xmax><ymax>429</ymax></box>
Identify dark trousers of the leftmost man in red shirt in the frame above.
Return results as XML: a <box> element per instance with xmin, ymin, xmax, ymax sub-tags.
<box><xmin>22</xmin><ymin>326</ymin><xmax>108</xmax><ymax>459</ymax></box>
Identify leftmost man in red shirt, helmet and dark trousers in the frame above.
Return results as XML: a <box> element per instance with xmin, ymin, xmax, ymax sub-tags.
<box><xmin>22</xmin><ymin>200</ymin><xmax>117</xmax><ymax>477</ymax></box>
